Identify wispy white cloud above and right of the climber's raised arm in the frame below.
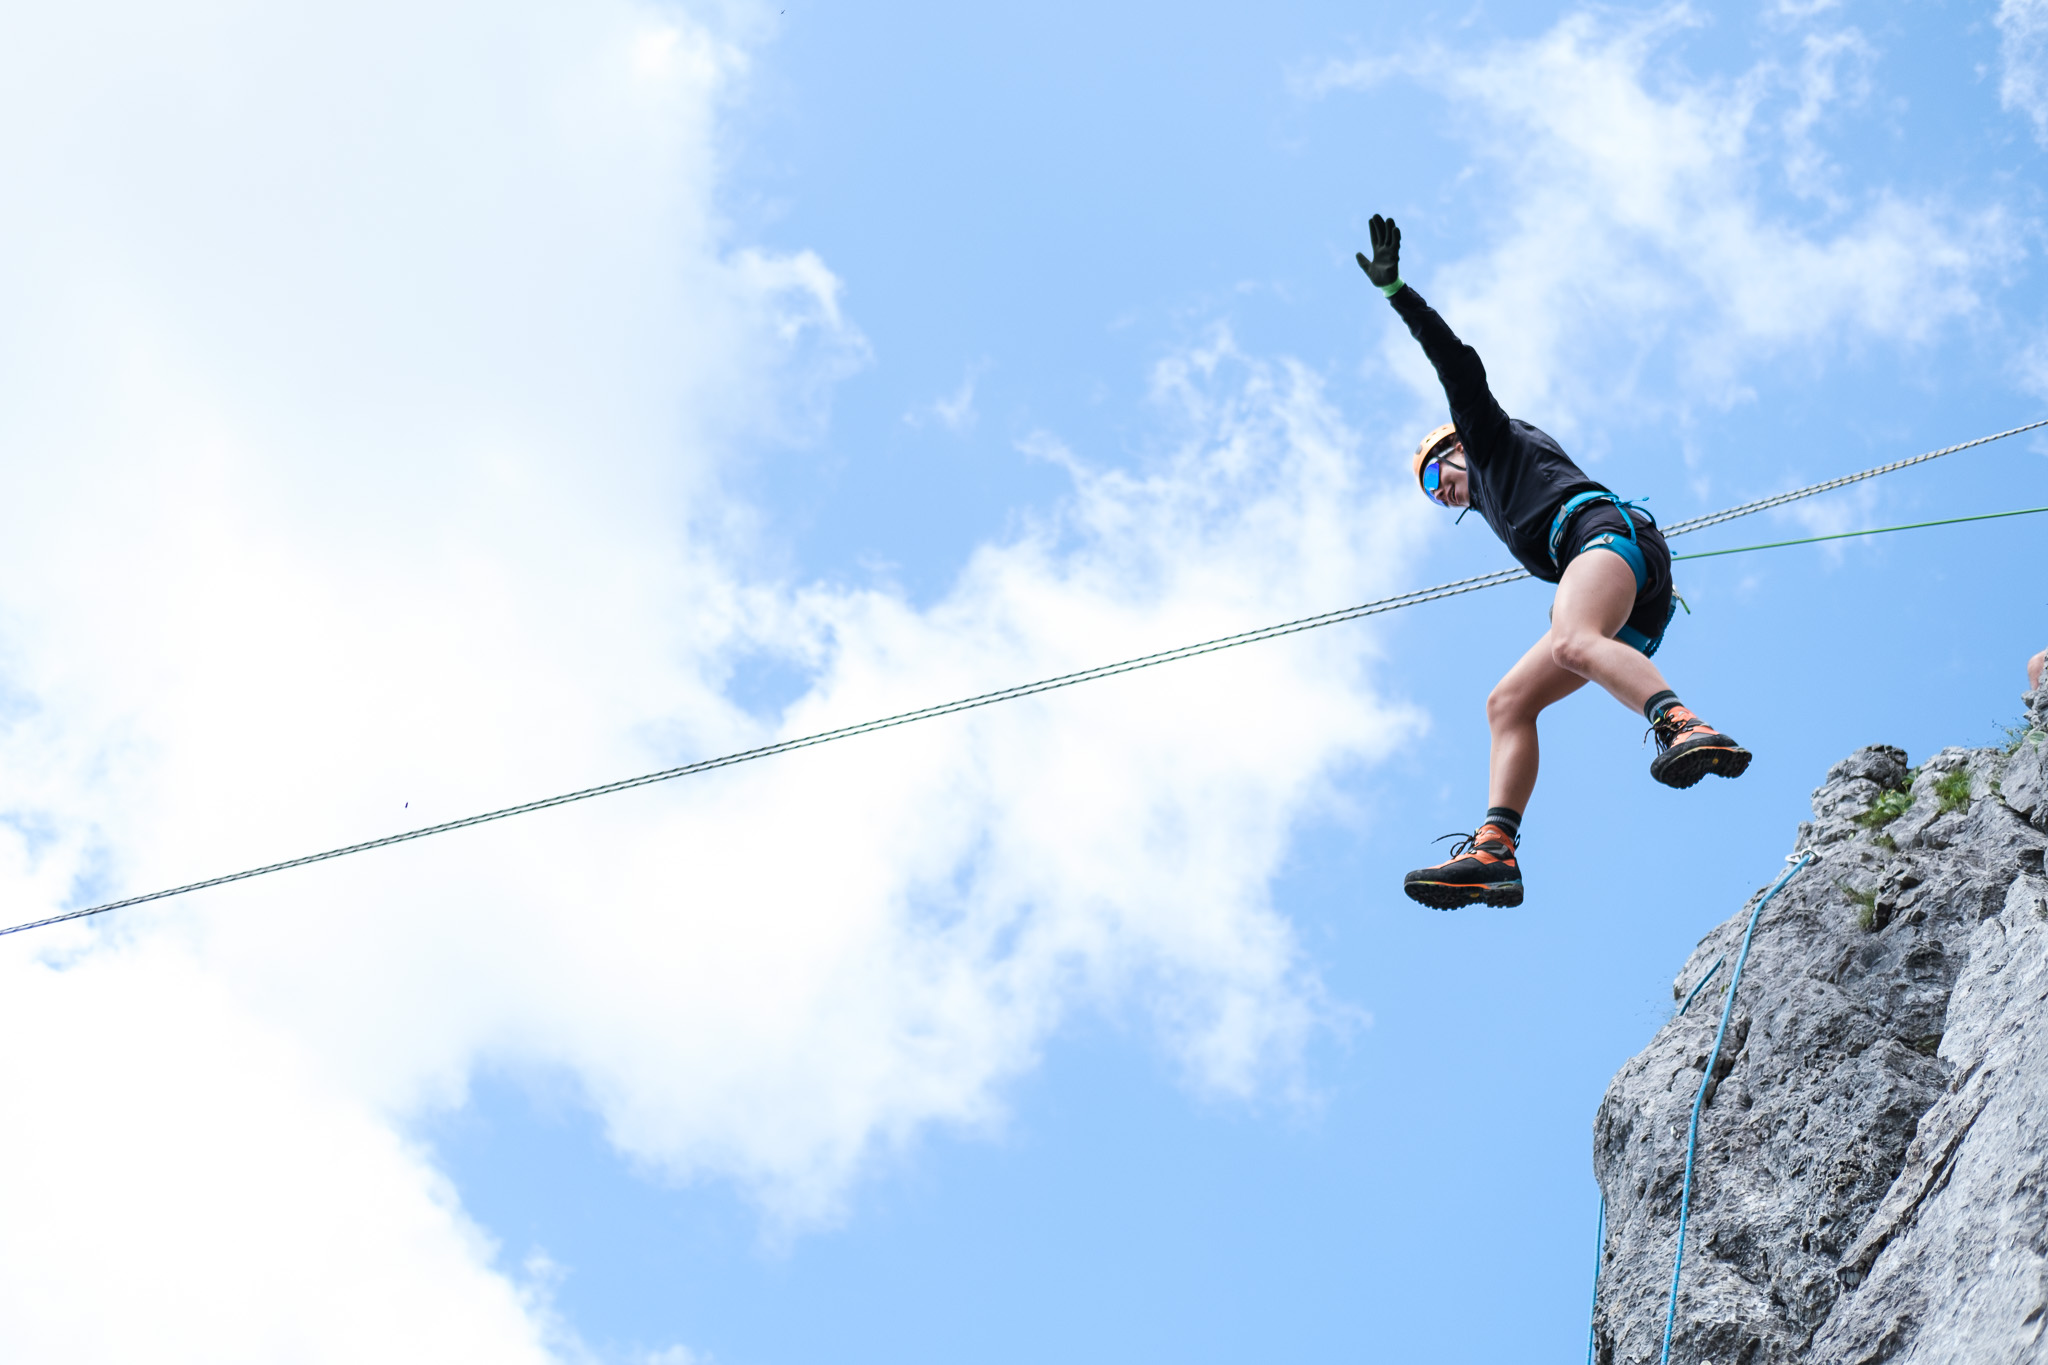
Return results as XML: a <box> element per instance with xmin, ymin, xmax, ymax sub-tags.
<box><xmin>1339</xmin><ymin>8</ymin><xmax>2017</xmax><ymax>444</ymax></box>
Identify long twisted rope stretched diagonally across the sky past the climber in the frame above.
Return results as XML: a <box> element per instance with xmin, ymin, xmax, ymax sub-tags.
<box><xmin>0</xmin><ymin>417</ymin><xmax>2048</xmax><ymax>937</ymax></box>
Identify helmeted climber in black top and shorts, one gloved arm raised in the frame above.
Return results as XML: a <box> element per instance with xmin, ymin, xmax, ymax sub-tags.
<box><xmin>1358</xmin><ymin>215</ymin><xmax>1749</xmax><ymax>911</ymax></box>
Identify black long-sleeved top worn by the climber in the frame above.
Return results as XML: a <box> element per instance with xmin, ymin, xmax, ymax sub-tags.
<box><xmin>1389</xmin><ymin>284</ymin><xmax>1606</xmax><ymax>583</ymax></box>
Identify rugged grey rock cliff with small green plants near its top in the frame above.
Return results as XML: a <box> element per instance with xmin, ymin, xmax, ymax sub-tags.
<box><xmin>1593</xmin><ymin>686</ymin><xmax>2048</xmax><ymax>1365</ymax></box>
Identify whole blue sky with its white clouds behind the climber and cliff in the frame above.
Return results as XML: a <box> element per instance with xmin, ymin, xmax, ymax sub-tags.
<box><xmin>0</xmin><ymin>0</ymin><xmax>2048</xmax><ymax>1365</ymax></box>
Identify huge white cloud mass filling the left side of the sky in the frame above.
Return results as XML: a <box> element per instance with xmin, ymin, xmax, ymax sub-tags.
<box><xmin>0</xmin><ymin>0</ymin><xmax>1421</xmax><ymax>1361</ymax></box>
